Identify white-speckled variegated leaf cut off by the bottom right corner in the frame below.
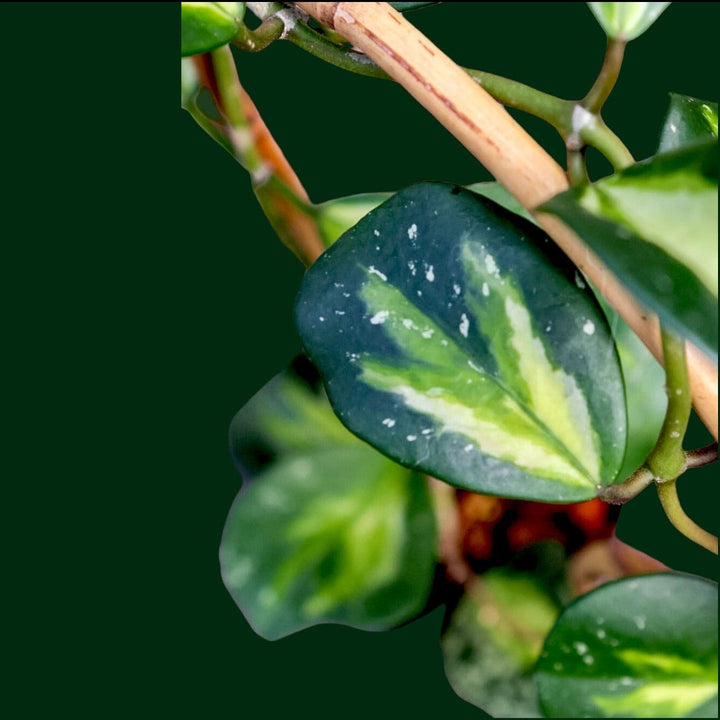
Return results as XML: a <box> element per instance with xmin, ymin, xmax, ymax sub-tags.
<box><xmin>537</xmin><ymin>573</ymin><xmax>718</xmax><ymax>718</ymax></box>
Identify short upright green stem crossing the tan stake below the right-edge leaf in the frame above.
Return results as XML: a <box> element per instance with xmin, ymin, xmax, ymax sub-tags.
<box><xmin>646</xmin><ymin>330</ymin><xmax>692</xmax><ymax>482</ymax></box>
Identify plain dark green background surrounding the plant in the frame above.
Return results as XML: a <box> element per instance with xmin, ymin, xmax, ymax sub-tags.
<box><xmin>0</xmin><ymin>3</ymin><xmax>719</xmax><ymax>718</ymax></box>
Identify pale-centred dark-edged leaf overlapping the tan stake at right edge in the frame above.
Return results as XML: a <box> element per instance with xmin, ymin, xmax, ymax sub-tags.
<box><xmin>542</xmin><ymin>141</ymin><xmax>718</xmax><ymax>358</ymax></box>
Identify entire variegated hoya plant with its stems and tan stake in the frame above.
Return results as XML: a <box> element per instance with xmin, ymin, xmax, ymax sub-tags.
<box><xmin>182</xmin><ymin>3</ymin><xmax>717</xmax><ymax>717</ymax></box>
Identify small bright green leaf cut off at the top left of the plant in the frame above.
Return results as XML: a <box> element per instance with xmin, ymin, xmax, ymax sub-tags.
<box><xmin>180</xmin><ymin>2</ymin><xmax>245</xmax><ymax>57</ymax></box>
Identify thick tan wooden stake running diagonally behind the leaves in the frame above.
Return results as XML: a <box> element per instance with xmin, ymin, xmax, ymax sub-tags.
<box><xmin>296</xmin><ymin>2</ymin><xmax>718</xmax><ymax>439</ymax></box>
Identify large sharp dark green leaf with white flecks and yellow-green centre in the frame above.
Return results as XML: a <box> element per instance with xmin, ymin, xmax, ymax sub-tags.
<box><xmin>296</xmin><ymin>183</ymin><xmax>626</xmax><ymax>502</ymax></box>
